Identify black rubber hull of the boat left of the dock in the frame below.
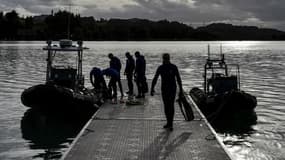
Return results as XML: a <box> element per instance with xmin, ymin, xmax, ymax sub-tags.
<box><xmin>21</xmin><ymin>84</ymin><xmax>100</xmax><ymax>112</ymax></box>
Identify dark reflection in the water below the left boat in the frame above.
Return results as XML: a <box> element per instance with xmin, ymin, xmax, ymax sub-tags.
<box><xmin>21</xmin><ymin>109</ymin><xmax>89</xmax><ymax>160</ymax></box>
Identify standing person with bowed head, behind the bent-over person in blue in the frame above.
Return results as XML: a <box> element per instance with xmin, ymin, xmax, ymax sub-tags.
<box><xmin>108</xmin><ymin>53</ymin><xmax>124</xmax><ymax>100</ymax></box>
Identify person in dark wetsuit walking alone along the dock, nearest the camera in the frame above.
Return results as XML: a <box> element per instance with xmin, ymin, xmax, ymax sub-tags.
<box><xmin>150</xmin><ymin>53</ymin><xmax>183</xmax><ymax>131</ymax></box>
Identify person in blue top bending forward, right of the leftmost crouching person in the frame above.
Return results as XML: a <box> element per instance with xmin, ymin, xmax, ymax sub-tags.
<box><xmin>102</xmin><ymin>68</ymin><xmax>123</xmax><ymax>102</ymax></box>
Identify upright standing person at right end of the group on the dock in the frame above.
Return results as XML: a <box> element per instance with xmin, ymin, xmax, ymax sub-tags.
<box><xmin>135</xmin><ymin>51</ymin><xmax>146</xmax><ymax>98</ymax></box>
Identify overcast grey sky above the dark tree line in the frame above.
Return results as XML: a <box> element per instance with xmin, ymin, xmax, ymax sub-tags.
<box><xmin>0</xmin><ymin>0</ymin><xmax>285</xmax><ymax>31</ymax></box>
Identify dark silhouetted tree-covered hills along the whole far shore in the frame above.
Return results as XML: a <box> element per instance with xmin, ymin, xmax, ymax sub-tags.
<box><xmin>0</xmin><ymin>10</ymin><xmax>285</xmax><ymax>41</ymax></box>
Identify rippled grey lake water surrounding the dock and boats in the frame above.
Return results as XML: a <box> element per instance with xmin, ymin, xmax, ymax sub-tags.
<box><xmin>0</xmin><ymin>41</ymin><xmax>285</xmax><ymax>160</ymax></box>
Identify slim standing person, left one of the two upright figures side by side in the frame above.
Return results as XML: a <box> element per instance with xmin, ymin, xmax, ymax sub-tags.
<box><xmin>125</xmin><ymin>52</ymin><xmax>135</xmax><ymax>96</ymax></box>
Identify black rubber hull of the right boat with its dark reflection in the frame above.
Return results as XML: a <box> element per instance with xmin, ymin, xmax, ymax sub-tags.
<box><xmin>190</xmin><ymin>88</ymin><xmax>257</xmax><ymax>131</ymax></box>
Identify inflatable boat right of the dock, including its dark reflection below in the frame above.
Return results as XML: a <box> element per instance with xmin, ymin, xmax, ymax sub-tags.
<box><xmin>190</xmin><ymin>44</ymin><xmax>257</xmax><ymax>130</ymax></box>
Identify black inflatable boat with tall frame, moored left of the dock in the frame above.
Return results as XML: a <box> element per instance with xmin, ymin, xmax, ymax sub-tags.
<box><xmin>21</xmin><ymin>40</ymin><xmax>101</xmax><ymax>112</ymax></box>
